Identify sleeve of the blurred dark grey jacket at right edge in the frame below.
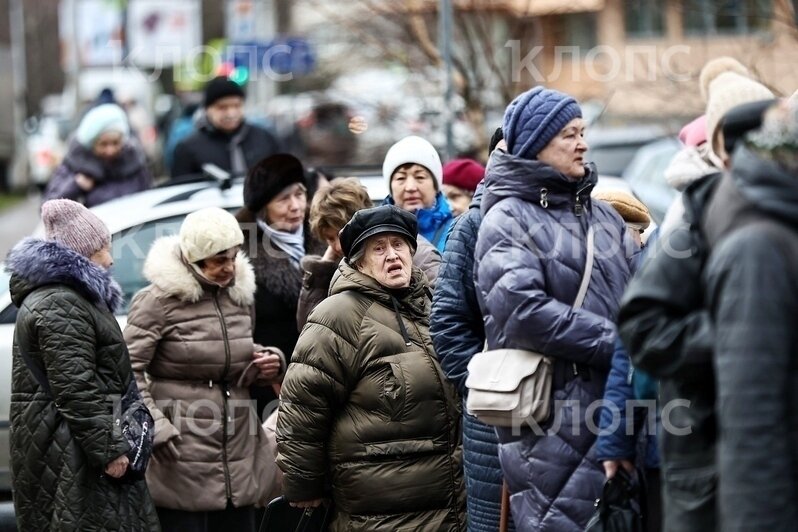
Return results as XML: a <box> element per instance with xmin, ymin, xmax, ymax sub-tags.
<box><xmin>707</xmin><ymin>229</ymin><xmax>798</xmax><ymax>531</ymax></box>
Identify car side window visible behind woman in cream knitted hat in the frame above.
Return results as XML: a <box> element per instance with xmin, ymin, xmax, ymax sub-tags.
<box><xmin>111</xmin><ymin>215</ymin><xmax>185</xmax><ymax>314</ymax></box>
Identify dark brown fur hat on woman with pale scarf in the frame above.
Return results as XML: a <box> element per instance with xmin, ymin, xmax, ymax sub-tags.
<box><xmin>244</xmin><ymin>153</ymin><xmax>305</xmax><ymax>213</ymax></box>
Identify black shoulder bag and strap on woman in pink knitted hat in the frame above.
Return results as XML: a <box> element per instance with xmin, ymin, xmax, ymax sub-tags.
<box><xmin>19</xmin><ymin>350</ymin><xmax>155</xmax><ymax>483</ymax></box>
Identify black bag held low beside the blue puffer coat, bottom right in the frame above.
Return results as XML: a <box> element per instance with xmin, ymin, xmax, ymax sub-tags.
<box><xmin>585</xmin><ymin>468</ymin><xmax>644</xmax><ymax>532</ymax></box>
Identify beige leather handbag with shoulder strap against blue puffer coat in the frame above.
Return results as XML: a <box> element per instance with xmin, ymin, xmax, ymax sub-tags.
<box><xmin>466</xmin><ymin>227</ymin><xmax>594</xmax><ymax>427</ymax></box>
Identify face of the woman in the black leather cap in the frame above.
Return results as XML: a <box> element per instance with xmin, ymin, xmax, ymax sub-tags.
<box><xmin>358</xmin><ymin>233</ymin><xmax>413</xmax><ymax>288</ymax></box>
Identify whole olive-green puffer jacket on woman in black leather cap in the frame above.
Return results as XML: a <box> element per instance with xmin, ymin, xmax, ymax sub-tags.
<box><xmin>277</xmin><ymin>263</ymin><xmax>466</xmax><ymax>531</ymax></box>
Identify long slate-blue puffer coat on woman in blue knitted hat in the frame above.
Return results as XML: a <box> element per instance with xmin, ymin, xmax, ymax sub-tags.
<box><xmin>475</xmin><ymin>152</ymin><xmax>634</xmax><ymax>532</ymax></box>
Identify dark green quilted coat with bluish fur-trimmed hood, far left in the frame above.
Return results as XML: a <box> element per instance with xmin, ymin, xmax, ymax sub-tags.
<box><xmin>8</xmin><ymin>239</ymin><xmax>160</xmax><ymax>532</ymax></box>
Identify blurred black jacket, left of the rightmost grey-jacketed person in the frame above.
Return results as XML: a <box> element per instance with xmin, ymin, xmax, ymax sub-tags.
<box><xmin>618</xmin><ymin>174</ymin><xmax>720</xmax><ymax>466</ymax></box>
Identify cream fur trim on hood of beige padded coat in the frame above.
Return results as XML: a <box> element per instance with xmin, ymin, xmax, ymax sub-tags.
<box><xmin>144</xmin><ymin>236</ymin><xmax>256</xmax><ymax>307</ymax></box>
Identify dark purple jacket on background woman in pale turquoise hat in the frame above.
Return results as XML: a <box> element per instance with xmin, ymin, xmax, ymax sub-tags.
<box><xmin>44</xmin><ymin>140</ymin><xmax>152</xmax><ymax>207</ymax></box>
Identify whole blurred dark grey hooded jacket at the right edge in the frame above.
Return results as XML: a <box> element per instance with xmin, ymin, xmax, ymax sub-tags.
<box><xmin>702</xmin><ymin>145</ymin><xmax>798</xmax><ymax>531</ymax></box>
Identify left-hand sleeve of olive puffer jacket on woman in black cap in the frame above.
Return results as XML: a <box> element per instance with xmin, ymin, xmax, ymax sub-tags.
<box><xmin>277</xmin><ymin>316</ymin><xmax>358</xmax><ymax>501</ymax></box>
